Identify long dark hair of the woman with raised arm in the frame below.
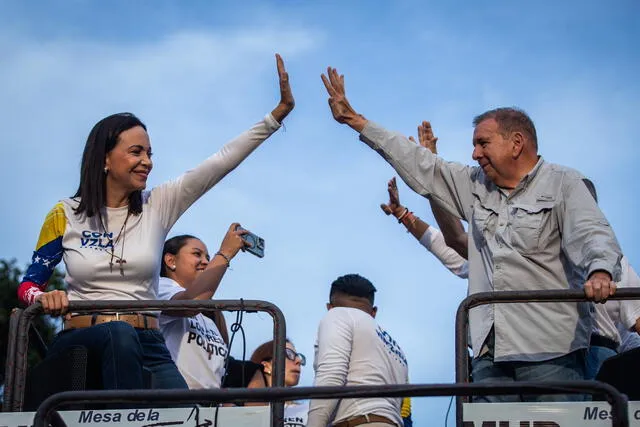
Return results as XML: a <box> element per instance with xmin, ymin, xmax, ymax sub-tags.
<box><xmin>73</xmin><ymin>113</ymin><xmax>147</xmax><ymax>221</ymax></box>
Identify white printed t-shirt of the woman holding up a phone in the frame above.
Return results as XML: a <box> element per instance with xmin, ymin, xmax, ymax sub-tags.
<box><xmin>158</xmin><ymin>277</ymin><xmax>228</xmax><ymax>389</ymax></box>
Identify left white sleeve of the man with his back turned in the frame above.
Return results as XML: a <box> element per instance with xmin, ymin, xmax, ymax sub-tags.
<box><xmin>307</xmin><ymin>308</ymin><xmax>353</xmax><ymax>427</ymax></box>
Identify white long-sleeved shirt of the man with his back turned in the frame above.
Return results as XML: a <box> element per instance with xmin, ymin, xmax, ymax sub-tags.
<box><xmin>307</xmin><ymin>307</ymin><xmax>409</xmax><ymax>427</ymax></box>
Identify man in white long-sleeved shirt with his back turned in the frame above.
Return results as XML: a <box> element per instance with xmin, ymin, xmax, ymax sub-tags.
<box><xmin>307</xmin><ymin>274</ymin><xmax>408</xmax><ymax>427</ymax></box>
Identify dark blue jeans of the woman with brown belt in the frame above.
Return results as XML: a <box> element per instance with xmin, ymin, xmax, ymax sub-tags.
<box><xmin>49</xmin><ymin>322</ymin><xmax>187</xmax><ymax>390</ymax></box>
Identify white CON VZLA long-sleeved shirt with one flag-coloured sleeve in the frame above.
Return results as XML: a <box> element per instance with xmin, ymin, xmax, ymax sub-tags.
<box><xmin>22</xmin><ymin>114</ymin><xmax>280</xmax><ymax>304</ymax></box>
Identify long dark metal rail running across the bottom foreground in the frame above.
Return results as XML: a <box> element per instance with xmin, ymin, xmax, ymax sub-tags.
<box><xmin>33</xmin><ymin>381</ymin><xmax>629</xmax><ymax>427</ymax></box>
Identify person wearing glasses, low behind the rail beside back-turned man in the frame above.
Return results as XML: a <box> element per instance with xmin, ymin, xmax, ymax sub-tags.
<box><xmin>249</xmin><ymin>339</ymin><xmax>309</xmax><ymax>427</ymax></box>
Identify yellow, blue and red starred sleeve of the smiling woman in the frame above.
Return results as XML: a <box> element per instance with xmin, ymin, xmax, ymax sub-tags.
<box><xmin>18</xmin><ymin>203</ymin><xmax>67</xmax><ymax>304</ymax></box>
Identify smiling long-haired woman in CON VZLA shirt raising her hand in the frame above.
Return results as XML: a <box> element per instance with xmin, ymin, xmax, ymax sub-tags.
<box><xmin>18</xmin><ymin>55</ymin><xmax>294</xmax><ymax>389</ymax></box>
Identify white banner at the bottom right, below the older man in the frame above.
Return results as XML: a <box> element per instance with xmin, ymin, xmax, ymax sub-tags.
<box><xmin>463</xmin><ymin>402</ymin><xmax>640</xmax><ymax>427</ymax></box>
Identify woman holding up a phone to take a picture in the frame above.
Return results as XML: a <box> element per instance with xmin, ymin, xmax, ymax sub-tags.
<box><xmin>158</xmin><ymin>227</ymin><xmax>264</xmax><ymax>389</ymax></box>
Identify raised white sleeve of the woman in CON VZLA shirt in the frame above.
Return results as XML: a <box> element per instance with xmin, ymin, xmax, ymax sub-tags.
<box><xmin>150</xmin><ymin>114</ymin><xmax>280</xmax><ymax>230</ymax></box>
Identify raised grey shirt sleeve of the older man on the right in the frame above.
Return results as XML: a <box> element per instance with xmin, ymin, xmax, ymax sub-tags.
<box><xmin>360</xmin><ymin>122</ymin><xmax>473</xmax><ymax>220</ymax></box>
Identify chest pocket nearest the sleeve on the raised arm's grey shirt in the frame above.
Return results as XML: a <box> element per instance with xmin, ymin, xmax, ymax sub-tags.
<box><xmin>509</xmin><ymin>202</ymin><xmax>553</xmax><ymax>254</ymax></box>
